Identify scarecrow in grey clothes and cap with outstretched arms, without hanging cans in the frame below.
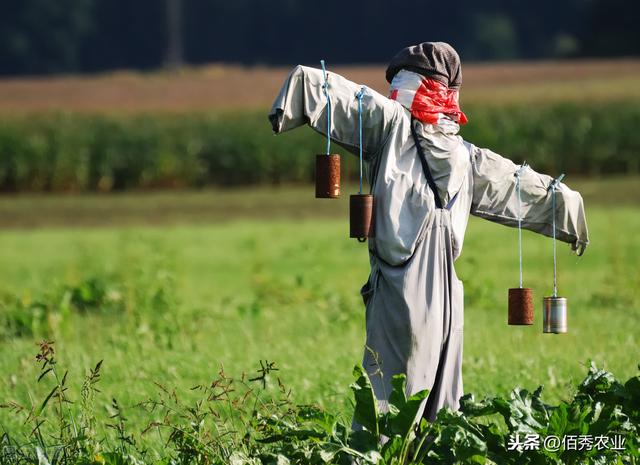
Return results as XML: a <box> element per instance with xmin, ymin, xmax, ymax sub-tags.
<box><xmin>269</xmin><ymin>42</ymin><xmax>588</xmax><ymax>421</ymax></box>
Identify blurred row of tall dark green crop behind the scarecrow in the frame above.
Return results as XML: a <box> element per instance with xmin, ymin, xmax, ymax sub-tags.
<box><xmin>0</xmin><ymin>102</ymin><xmax>640</xmax><ymax>192</ymax></box>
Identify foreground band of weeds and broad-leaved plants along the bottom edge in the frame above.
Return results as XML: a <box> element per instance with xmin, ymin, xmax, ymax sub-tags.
<box><xmin>0</xmin><ymin>341</ymin><xmax>640</xmax><ymax>465</ymax></box>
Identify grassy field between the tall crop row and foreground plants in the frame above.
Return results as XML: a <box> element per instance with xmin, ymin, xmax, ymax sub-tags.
<box><xmin>0</xmin><ymin>183</ymin><xmax>640</xmax><ymax>454</ymax></box>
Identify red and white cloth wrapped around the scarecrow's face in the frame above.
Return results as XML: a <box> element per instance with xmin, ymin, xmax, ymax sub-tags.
<box><xmin>389</xmin><ymin>70</ymin><xmax>468</xmax><ymax>124</ymax></box>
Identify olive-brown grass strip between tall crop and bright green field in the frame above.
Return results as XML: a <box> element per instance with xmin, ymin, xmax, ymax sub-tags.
<box><xmin>0</xmin><ymin>176</ymin><xmax>640</xmax><ymax>229</ymax></box>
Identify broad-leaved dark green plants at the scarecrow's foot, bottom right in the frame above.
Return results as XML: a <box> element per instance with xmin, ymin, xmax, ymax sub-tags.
<box><xmin>241</xmin><ymin>364</ymin><xmax>640</xmax><ymax>465</ymax></box>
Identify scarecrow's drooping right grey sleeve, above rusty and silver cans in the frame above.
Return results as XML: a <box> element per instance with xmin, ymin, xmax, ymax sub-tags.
<box><xmin>469</xmin><ymin>144</ymin><xmax>589</xmax><ymax>255</ymax></box>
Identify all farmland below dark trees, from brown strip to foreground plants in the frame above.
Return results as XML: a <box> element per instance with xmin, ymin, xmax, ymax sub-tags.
<box><xmin>0</xmin><ymin>60</ymin><xmax>640</xmax><ymax>465</ymax></box>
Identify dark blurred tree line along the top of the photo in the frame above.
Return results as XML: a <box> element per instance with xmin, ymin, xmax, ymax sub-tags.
<box><xmin>0</xmin><ymin>0</ymin><xmax>640</xmax><ymax>75</ymax></box>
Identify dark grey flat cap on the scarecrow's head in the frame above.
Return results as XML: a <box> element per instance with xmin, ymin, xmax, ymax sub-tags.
<box><xmin>386</xmin><ymin>42</ymin><xmax>462</xmax><ymax>89</ymax></box>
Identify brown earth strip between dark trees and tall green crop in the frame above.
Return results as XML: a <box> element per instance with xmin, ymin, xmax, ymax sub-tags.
<box><xmin>0</xmin><ymin>59</ymin><xmax>640</xmax><ymax>114</ymax></box>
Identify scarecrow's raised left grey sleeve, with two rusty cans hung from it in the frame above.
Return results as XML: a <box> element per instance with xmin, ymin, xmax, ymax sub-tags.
<box><xmin>269</xmin><ymin>66</ymin><xmax>398</xmax><ymax>158</ymax></box>
